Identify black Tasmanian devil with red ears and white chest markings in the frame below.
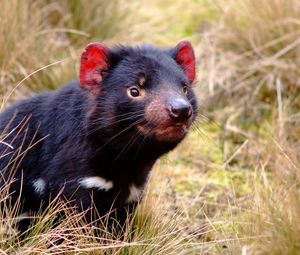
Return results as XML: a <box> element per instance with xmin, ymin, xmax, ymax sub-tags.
<box><xmin>0</xmin><ymin>41</ymin><xmax>197</xmax><ymax>233</ymax></box>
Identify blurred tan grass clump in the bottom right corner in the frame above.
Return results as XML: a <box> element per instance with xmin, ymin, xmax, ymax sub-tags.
<box><xmin>242</xmin><ymin>136</ymin><xmax>300</xmax><ymax>254</ymax></box>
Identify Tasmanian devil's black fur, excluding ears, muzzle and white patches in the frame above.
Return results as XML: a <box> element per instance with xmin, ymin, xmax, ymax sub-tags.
<box><xmin>0</xmin><ymin>43</ymin><xmax>197</xmax><ymax>231</ymax></box>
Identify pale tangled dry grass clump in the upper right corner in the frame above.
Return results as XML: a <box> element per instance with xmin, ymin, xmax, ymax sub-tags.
<box><xmin>199</xmin><ymin>0</ymin><xmax>300</xmax><ymax>128</ymax></box>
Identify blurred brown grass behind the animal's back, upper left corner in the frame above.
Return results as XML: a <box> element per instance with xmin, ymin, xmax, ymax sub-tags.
<box><xmin>0</xmin><ymin>0</ymin><xmax>131</xmax><ymax>107</ymax></box>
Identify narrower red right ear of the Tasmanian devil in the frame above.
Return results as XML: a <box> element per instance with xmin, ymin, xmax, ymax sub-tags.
<box><xmin>175</xmin><ymin>41</ymin><xmax>196</xmax><ymax>83</ymax></box>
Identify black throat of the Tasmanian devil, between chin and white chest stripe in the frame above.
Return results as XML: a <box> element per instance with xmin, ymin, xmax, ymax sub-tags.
<box><xmin>84</xmin><ymin>126</ymin><xmax>176</xmax><ymax>185</ymax></box>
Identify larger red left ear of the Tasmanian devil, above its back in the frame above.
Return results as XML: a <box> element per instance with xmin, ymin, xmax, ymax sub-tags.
<box><xmin>79</xmin><ymin>42</ymin><xmax>109</xmax><ymax>95</ymax></box>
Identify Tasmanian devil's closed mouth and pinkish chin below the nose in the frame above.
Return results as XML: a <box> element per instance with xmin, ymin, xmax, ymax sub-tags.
<box><xmin>137</xmin><ymin>123</ymin><xmax>190</xmax><ymax>142</ymax></box>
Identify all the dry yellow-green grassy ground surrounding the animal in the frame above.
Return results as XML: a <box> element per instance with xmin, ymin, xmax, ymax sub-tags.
<box><xmin>0</xmin><ymin>0</ymin><xmax>300</xmax><ymax>255</ymax></box>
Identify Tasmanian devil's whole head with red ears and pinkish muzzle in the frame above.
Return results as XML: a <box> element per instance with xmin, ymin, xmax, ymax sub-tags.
<box><xmin>80</xmin><ymin>41</ymin><xmax>197</xmax><ymax>152</ymax></box>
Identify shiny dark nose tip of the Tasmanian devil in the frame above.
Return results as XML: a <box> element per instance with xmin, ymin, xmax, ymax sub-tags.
<box><xmin>168</xmin><ymin>98</ymin><xmax>192</xmax><ymax>123</ymax></box>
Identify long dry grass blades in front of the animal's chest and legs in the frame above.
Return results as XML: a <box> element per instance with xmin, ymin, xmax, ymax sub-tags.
<box><xmin>0</xmin><ymin>165</ymin><xmax>214</xmax><ymax>255</ymax></box>
